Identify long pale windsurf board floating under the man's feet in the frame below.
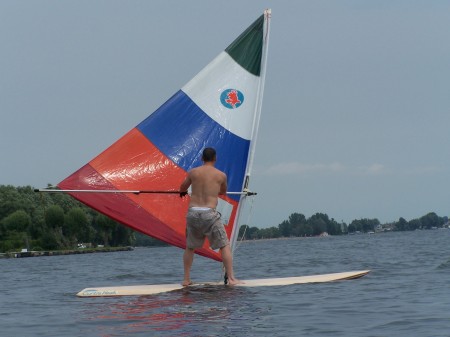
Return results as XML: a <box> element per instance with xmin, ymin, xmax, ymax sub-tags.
<box><xmin>77</xmin><ymin>270</ymin><xmax>370</xmax><ymax>297</ymax></box>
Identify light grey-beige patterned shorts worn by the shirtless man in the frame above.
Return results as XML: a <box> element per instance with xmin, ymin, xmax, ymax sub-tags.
<box><xmin>186</xmin><ymin>208</ymin><xmax>230</xmax><ymax>250</ymax></box>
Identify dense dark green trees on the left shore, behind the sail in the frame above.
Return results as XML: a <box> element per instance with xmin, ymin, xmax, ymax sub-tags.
<box><xmin>0</xmin><ymin>185</ymin><xmax>159</xmax><ymax>252</ymax></box>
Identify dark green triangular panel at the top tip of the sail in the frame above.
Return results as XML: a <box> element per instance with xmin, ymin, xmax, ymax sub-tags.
<box><xmin>225</xmin><ymin>15</ymin><xmax>264</xmax><ymax>76</ymax></box>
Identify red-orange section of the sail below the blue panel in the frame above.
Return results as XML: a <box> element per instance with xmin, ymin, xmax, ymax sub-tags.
<box><xmin>58</xmin><ymin>129</ymin><xmax>221</xmax><ymax>261</ymax></box>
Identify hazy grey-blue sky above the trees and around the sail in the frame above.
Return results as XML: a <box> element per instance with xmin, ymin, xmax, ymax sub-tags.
<box><xmin>0</xmin><ymin>0</ymin><xmax>450</xmax><ymax>228</ymax></box>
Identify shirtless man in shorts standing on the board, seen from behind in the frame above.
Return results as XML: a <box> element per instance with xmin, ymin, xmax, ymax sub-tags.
<box><xmin>180</xmin><ymin>147</ymin><xmax>242</xmax><ymax>286</ymax></box>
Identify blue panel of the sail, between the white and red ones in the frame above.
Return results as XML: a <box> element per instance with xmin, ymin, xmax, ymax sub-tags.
<box><xmin>137</xmin><ymin>90</ymin><xmax>250</xmax><ymax>200</ymax></box>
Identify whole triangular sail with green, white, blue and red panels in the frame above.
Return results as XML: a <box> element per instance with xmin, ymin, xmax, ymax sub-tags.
<box><xmin>58</xmin><ymin>10</ymin><xmax>270</xmax><ymax>261</ymax></box>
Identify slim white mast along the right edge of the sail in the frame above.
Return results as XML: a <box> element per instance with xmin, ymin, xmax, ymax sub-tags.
<box><xmin>230</xmin><ymin>9</ymin><xmax>272</xmax><ymax>254</ymax></box>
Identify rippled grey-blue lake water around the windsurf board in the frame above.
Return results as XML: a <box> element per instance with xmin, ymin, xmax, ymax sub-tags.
<box><xmin>0</xmin><ymin>229</ymin><xmax>450</xmax><ymax>337</ymax></box>
